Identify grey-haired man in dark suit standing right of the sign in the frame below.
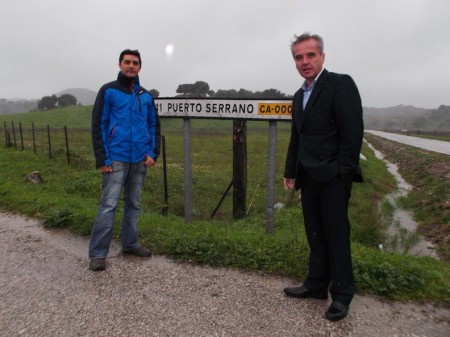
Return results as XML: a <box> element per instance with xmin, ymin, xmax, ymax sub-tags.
<box><xmin>283</xmin><ymin>33</ymin><xmax>364</xmax><ymax>321</ymax></box>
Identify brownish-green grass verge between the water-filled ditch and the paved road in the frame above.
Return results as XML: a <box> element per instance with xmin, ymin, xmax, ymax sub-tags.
<box><xmin>366</xmin><ymin>134</ymin><xmax>450</xmax><ymax>262</ymax></box>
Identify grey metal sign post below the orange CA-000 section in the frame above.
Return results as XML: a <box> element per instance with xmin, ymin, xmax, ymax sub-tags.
<box><xmin>266</xmin><ymin>121</ymin><xmax>277</xmax><ymax>233</ymax></box>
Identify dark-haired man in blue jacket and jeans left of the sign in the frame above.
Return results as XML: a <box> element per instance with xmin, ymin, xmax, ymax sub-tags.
<box><xmin>89</xmin><ymin>49</ymin><xmax>160</xmax><ymax>271</ymax></box>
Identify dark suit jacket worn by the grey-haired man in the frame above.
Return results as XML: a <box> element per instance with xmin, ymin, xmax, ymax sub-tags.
<box><xmin>284</xmin><ymin>69</ymin><xmax>364</xmax><ymax>189</ymax></box>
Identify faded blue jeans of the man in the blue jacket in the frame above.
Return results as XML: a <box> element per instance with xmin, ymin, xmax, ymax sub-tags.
<box><xmin>89</xmin><ymin>161</ymin><xmax>147</xmax><ymax>259</ymax></box>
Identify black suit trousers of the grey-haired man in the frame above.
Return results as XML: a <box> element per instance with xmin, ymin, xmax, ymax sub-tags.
<box><xmin>300</xmin><ymin>170</ymin><xmax>355</xmax><ymax>305</ymax></box>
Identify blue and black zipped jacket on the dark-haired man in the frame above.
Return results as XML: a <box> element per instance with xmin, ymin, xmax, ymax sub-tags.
<box><xmin>91</xmin><ymin>72</ymin><xmax>161</xmax><ymax>168</ymax></box>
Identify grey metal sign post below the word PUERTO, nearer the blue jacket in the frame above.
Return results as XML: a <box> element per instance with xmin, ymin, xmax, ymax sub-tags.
<box><xmin>183</xmin><ymin>118</ymin><xmax>193</xmax><ymax>223</ymax></box>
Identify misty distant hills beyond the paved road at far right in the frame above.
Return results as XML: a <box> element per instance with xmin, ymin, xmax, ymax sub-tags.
<box><xmin>363</xmin><ymin>105</ymin><xmax>450</xmax><ymax>131</ymax></box>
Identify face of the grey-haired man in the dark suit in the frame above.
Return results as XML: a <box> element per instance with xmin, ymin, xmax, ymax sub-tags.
<box><xmin>294</xmin><ymin>39</ymin><xmax>325</xmax><ymax>84</ymax></box>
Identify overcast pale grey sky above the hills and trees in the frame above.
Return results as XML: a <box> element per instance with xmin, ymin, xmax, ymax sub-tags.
<box><xmin>0</xmin><ymin>0</ymin><xmax>450</xmax><ymax>108</ymax></box>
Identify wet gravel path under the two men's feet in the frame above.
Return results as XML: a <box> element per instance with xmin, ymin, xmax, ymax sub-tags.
<box><xmin>0</xmin><ymin>213</ymin><xmax>450</xmax><ymax>337</ymax></box>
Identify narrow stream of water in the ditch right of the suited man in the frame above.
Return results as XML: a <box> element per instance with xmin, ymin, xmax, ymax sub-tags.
<box><xmin>368</xmin><ymin>140</ymin><xmax>438</xmax><ymax>258</ymax></box>
